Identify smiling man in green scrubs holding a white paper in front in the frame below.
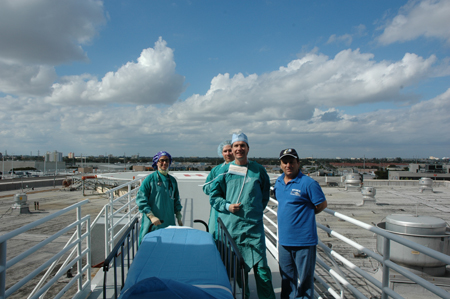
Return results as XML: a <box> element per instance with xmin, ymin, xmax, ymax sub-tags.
<box><xmin>210</xmin><ymin>133</ymin><xmax>275</xmax><ymax>299</ymax></box>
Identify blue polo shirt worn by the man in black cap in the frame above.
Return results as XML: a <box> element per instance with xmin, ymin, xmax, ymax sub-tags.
<box><xmin>274</xmin><ymin>171</ymin><xmax>326</xmax><ymax>246</ymax></box>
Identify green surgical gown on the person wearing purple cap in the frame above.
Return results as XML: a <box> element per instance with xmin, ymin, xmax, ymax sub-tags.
<box><xmin>136</xmin><ymin>171</ymin><xmax>182</xmax><ymax>244</ymax></box>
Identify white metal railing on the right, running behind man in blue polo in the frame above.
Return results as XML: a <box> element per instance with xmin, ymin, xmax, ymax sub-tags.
<box><xmin>264</xmin><ymin>199</ymin><xmax>450</xmax><ymax>299</ymax></box>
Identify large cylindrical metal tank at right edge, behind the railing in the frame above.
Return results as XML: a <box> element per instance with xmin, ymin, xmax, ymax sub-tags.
<box><xmin>377</xmin><ymin>214</ymin><xmax>450</xmax><ymax>276</ymax></box>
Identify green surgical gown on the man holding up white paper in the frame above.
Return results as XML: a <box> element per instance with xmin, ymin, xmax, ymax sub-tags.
<box><xmin>210</xmin><ymin>161</ymin><xmax>270</xmax><ymax>271</ymax></box>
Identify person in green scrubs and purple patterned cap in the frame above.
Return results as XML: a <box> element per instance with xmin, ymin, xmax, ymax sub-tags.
<box><xmin>136</xmin><ymin>151</ymin><xmax>183</xmax><ymax>244</ymax></box>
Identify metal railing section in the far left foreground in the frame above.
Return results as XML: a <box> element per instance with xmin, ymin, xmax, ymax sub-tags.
<box><xmin>0</xmin><ymin>200</ymin><xmax>91</xmax><ymax>299</ymax></box>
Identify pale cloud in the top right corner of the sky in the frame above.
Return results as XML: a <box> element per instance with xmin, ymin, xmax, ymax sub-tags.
<box><xmin>378</xmin><ymin>0</ymin><xmax>450</xmax><ymax>45</ymax></box>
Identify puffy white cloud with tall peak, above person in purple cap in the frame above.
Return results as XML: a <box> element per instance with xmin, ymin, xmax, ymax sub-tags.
<box><xmin>46</xmin><ymin>37</ymin><xmax>184</xmax><ymax>105</ymax></box>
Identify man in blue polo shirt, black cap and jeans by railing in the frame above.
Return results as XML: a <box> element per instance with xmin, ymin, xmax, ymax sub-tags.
<box><xmin>274</xmin><ymin>148</ymin><xmax>327</xmax><ymax>299</ymax></box>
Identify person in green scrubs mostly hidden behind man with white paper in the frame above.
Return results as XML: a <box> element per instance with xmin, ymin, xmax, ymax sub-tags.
<box><xmin>203</xmin><ymin>140</ymin><xmax>234</xmax><ymax>239</ymax></box>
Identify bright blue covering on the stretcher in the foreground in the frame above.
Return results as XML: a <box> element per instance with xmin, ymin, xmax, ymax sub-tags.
<box><xmin>120</xmin><ymin>227</ymin><xmax>233</xmax><ymax>299</ymax></box>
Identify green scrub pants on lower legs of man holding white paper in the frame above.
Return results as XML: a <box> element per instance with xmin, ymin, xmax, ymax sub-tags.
<box><xmin>239</xmin><ymin>259</ymin><xmax>275</xmax><ymax>299</ymax></box>
